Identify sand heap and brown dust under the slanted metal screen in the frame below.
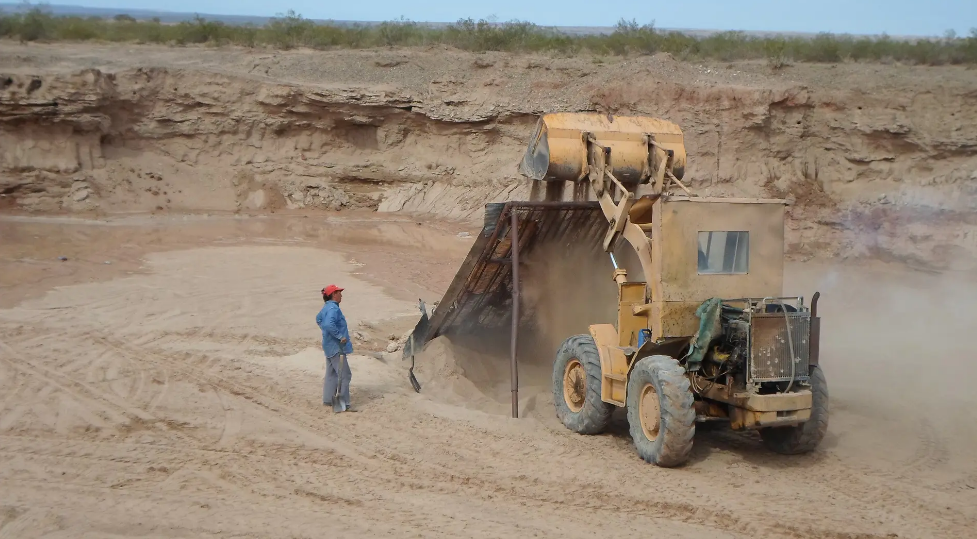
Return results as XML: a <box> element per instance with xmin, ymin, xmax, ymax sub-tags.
<box><xmin>417</xmin><ymin>240</ymin><xmax>617</xmax><ymax>414</ymax></box>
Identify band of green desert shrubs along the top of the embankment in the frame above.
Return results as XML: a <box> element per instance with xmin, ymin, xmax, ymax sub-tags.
<box><xmin>0</xmin><ymin>6</ymin><xmax>977</xmax><ymax>67</ymax></box>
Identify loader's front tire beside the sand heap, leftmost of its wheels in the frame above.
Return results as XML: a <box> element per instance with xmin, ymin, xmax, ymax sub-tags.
<box><xmin>553</xmin><ymin>335</ymin><xmax>614</xmax><ymax>434</ymax></box>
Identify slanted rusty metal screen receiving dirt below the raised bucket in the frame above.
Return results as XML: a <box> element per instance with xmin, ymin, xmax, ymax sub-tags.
<box><xmin>404</xmin><ymin>202</ymin><xmax>608</xmax><ymax>357</ymax></box>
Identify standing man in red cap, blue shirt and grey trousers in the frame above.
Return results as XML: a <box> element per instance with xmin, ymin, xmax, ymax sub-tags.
<box><xmin>315</xmin><ymin>284</ymin><xmax>355</xmax><ymax>412</ymax></box>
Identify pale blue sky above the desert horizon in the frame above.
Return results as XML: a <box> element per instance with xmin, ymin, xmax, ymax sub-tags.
<box><xmin>22</xmin><ymin>0</ymin><xmax>977</xmax><ymax>36</ymax></box>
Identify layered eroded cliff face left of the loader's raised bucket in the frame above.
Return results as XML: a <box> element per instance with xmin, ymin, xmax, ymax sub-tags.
<box><xmin>0</xmin><ymin>69</ymin><xmax>528</xmax><ymax>216</ymax></box>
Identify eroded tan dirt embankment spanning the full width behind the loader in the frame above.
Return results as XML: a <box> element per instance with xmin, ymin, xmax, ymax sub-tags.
<box><xmin>0</xmin><ymin>43</ymin><xmax>977</xmax><ymax>268</ymax></box>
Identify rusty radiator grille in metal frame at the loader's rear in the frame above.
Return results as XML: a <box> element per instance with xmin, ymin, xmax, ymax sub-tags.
<box><xmin>749</xmin><ymin>313</ymin><xmax>811</xmax><ymax>382</ymax></box>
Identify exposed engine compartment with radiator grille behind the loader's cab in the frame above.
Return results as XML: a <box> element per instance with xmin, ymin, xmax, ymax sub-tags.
<box><xmin>697</xmin><ymin>298</ymin><xmax>811</xmax><ymax>395</ymax></box>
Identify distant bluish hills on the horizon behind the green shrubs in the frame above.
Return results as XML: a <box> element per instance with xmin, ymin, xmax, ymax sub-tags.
<box><xmin>0</xmin><ymin>2</ymin><xmax>920</xmax><ymax>40</ymax></box>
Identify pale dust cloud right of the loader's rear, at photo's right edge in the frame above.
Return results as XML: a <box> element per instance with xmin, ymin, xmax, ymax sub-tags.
<box><xmin>785</xmin><ymin>263</ymin><xmax>977</xmax><ymax>479</ymax></box>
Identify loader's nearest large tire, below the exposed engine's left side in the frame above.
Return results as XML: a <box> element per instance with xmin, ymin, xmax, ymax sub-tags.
<box><xmin>627</xmin><ymin>356</ymin><xmax>695</xmax><ymax>468</ymax></box>
